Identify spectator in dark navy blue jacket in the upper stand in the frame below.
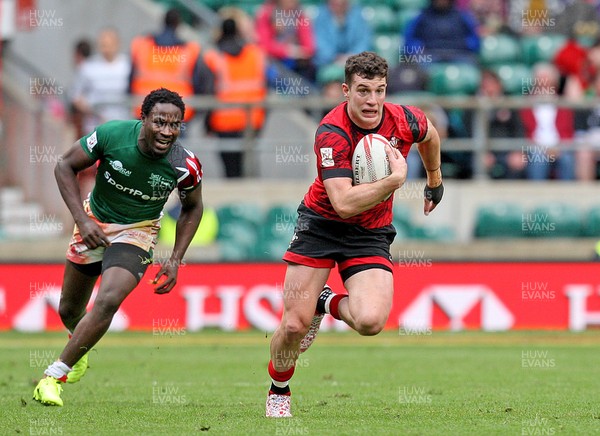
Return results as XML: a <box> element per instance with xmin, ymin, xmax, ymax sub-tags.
<box><xmin>404</xmin><ymin>0</ymin><xmax>480</xmax><ymax>63</ymax></box>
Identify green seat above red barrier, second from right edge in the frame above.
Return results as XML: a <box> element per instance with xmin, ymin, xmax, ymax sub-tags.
<box><xmin>522</xmin><ymin>203</ymin><xmax>583</xmax><ymax>238</ymax></box>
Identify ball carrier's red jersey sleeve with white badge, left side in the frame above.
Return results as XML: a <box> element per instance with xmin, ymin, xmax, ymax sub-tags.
<box><xmin>315</xmin><ymin>124</ymin><xmax>352</xmax><ymax>180</ymax></box>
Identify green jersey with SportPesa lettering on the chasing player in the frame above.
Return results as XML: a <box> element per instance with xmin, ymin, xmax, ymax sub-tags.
<box><xmin>79</xmin><ymin>120</ymin><xmax>202</xmax><ymax>224</ymax></box>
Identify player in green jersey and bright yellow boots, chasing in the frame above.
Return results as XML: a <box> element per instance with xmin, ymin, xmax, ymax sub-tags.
<box><xmin>33</xmin><ymin>88</ymin><xmax>203</xmax><ymax>406</ymax></box>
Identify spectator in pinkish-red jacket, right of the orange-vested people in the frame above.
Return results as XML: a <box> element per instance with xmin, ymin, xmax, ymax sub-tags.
<box><xmin>256</xmin><ymin>0</ymin><xmax>316</xmax><ymax>84</ymax></box>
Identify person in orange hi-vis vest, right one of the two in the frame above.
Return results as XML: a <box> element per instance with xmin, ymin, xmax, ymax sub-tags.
<box><xmin>201</xmin><ymin>18</ymin><xmax>267</xmax><ymax>177</ymax></box>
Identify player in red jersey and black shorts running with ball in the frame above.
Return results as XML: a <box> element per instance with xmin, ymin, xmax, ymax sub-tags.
<box><xmin>266</xmin><ymin>52</ymin><xmax>444</xmax><ymax>418</ymax></box>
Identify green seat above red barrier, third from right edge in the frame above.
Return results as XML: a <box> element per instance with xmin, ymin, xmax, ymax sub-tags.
<box><xmin>475</xmin><ymin>203</ymin><xmax>525</xmax><ymax>238</ymax></box>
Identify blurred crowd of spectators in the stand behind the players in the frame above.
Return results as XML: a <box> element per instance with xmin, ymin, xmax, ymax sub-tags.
<box><xmin>70</xmin><ymin>0</ymin><xmax>600</xmax><ymax>180</ymax></box>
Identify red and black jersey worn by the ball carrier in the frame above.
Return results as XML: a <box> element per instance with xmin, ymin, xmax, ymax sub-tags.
<box><xmin>304</xmin><ymin>102</ymin><xmax>427</xmax><ymax>229</ymax></box>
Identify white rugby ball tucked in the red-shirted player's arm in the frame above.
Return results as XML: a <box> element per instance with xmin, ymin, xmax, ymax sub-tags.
<box><xmin>352</xmin><ymin>133</ymin><xmax>391</xmax><ymax>185</ymax></box>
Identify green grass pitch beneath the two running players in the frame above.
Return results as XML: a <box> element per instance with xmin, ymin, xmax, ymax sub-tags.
<box><xmin>0</xmin><ymin>331</ymin><xmax>600</xmax><ymax>435</ymax></box>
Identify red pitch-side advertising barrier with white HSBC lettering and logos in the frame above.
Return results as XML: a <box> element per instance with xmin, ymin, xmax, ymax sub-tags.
<box><xmin>0</xmin><ymin>259</ymin><xmax>600</xmax><ymax>335</ymax></box>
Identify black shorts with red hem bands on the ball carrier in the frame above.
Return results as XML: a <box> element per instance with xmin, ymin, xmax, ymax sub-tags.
<box><xmin>283</xmin><ymin>202</ymin><xmax>396</xmax><ymax>281</ymax></box>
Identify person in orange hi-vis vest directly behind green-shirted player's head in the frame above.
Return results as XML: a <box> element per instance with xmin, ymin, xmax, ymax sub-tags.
<box><xmin>129</xmin><ymin>9</ymin><xmax>203</xmax><ymax>122</ymax></box>
